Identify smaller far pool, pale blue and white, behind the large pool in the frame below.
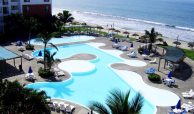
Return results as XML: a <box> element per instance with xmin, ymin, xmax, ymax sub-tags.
<box><xmin>30</xmin><ymin>35</ymin><xmax>95</xmax><ymax>45</ymax></box>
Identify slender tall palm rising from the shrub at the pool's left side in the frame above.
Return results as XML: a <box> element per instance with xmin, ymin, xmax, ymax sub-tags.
<box><xmin>36</xmin><ymin>30</ymin><xmax>58</xmax><ymax>69</ymax></box>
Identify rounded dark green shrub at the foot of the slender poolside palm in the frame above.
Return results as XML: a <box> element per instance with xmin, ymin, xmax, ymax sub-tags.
<box><xmin>38</xmin><ymin>67</ymin><xmax>54</xmax><ymax>78</ymax></box>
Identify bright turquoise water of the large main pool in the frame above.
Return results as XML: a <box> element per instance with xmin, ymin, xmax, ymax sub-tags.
<box><xmin>27</xmin><ymin>44</ymin><xmax>156</xmax><ymax>114</ymax></box>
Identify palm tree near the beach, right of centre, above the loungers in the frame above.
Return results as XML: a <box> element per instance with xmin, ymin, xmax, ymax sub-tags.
<box><xmin>145</xmin><ymin>28</ymin><xmax>159</xmax><ymax>51</ymax></box>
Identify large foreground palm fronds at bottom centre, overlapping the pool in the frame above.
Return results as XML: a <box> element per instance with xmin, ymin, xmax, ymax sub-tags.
<box><xmin>89</xmin><ymin>90</ymin><xmax>143</xmax><ymax>114</ymax></box>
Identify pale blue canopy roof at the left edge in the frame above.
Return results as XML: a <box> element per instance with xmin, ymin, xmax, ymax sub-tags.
<box><xmin>0</xmin><ymin>46</ymin><xmax>19</xmax><ymax>60</ymax></box>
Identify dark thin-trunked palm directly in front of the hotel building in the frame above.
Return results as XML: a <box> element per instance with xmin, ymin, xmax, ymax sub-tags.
<box><xmin>24</xmin><ymin>17</ymin><xmax>39</xmax><ymax>45</ymax></box>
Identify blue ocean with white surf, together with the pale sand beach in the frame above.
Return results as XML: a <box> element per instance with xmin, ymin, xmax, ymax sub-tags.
<box><xmin>53</xmin><ymin>0</ymin><xmax>194</xmax><ymax>42</ymax></box>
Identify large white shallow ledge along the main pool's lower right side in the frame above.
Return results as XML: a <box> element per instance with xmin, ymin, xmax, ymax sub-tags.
<box><xmin>113</xmin><ymin>69</ymin><xmax>180</xmax><ymax>106</ymax></box>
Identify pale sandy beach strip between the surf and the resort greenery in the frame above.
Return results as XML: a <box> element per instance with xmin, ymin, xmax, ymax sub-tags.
<box><xmin>53</xmin><ymin>8</ymin><xmax>190</xmax><ymax>49</ymax></box>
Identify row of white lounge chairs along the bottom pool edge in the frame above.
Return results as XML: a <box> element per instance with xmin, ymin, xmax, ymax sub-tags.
<box><xmin>49</xmin><ymin>101</ymin><xmax>76</xmax><ymax>114</ymax></box>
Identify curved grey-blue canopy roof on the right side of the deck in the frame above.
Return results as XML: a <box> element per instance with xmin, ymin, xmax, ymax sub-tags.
<box><xmin>161</xmin><ymin>47</ymin><xmax>185</xmax><ymax>63</ymax></box>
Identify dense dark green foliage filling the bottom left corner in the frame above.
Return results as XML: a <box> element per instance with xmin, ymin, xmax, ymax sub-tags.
<box><xmin>0</xmin><ymin>80</ymin><xmax>51</xmax><ymax>114</ymax></box>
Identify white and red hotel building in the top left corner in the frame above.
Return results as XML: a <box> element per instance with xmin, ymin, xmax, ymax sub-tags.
<box><xmin>0</xmin><ymin>0</ymin><xmax>52</xmax><ymax>33</ymax></box>
